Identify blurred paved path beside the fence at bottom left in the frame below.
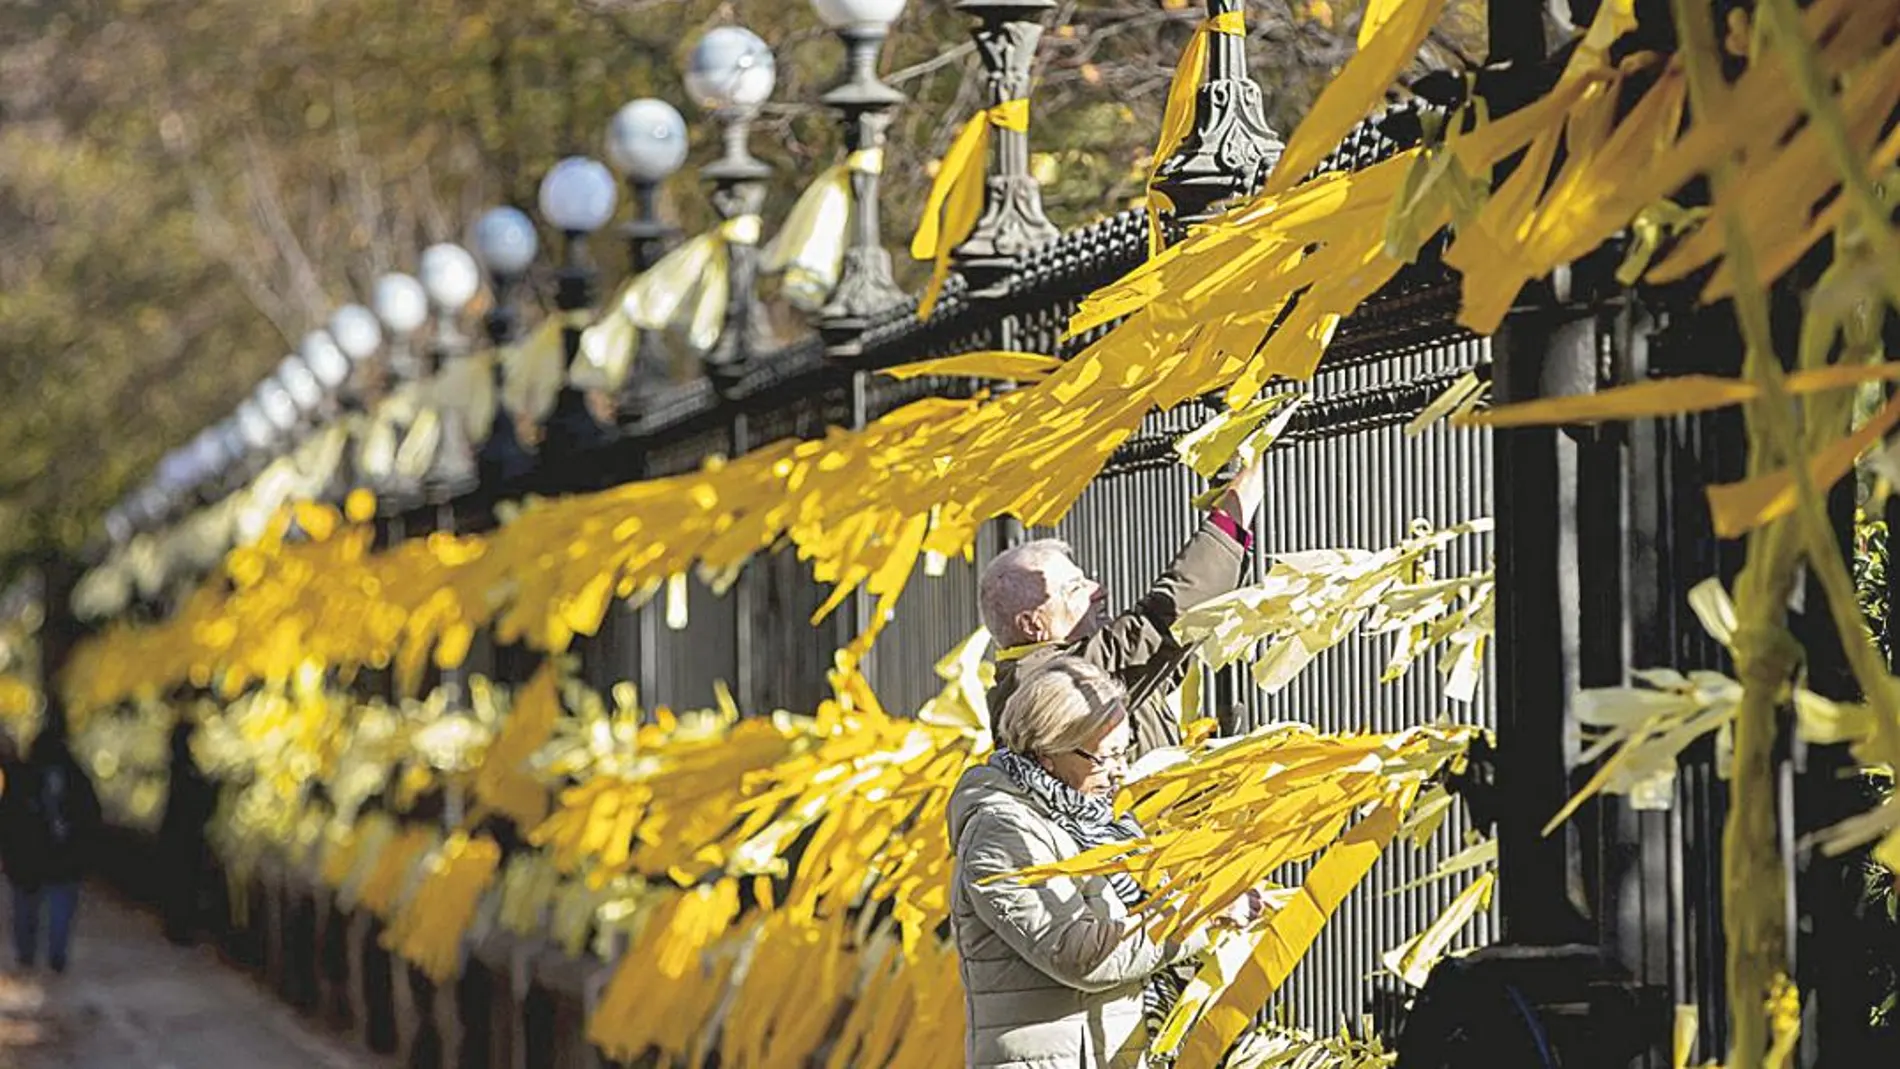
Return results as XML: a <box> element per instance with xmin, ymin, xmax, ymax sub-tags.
<box><xmin>0</xmin><ymin>887</ymin><xmax>384</xmax><ymax>1069</ymax></box>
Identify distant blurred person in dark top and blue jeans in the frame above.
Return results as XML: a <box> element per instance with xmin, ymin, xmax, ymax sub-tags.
<box><xmin>0</xmin><ymin>725</ymin><xmax>99</xmax><ymax>972</ymax></box>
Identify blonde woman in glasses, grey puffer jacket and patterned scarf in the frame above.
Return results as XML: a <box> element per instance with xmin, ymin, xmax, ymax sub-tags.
<box><xmin>950</xmin><ymin>657</ymin><xmax>1254</xmax><ymax>1069</ymax></box>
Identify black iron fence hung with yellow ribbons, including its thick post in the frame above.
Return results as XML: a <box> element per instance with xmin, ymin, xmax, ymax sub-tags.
<box><xmin>122</xmin><ymin>73</ymin><xmax>1900</xmax><ymax>1065</ymax></box>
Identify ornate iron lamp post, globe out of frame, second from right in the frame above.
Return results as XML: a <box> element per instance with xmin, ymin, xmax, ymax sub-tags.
<box><xmin>954</xmin><ymin>0</ymin><xmax>1060</xmax><ymax>296</ymax></box>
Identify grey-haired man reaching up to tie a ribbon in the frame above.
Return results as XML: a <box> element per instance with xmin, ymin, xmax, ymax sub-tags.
<box><xmin>977</xmin><ymin>461</ymin><xmax>1262</xmax><ymax>758</ymax></box>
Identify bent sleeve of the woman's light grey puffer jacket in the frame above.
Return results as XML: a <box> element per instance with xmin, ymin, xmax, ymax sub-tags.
<box><xmin>956</xmin><ymin>809</ymin><xmax>1191</xmax><ymax>991</ymax></box>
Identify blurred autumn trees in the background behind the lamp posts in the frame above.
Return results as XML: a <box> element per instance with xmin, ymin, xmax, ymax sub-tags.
<box><xmin>0</xmin><ymin>0</ymin><xmax>1482</xmax><ymax>575</ymax></box>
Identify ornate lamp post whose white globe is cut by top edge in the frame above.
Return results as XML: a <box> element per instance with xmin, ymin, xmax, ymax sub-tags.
<box><xmin>811</xmin><ymin>0</ymin><xmax>904</xmax><ymax>357</ymax></box>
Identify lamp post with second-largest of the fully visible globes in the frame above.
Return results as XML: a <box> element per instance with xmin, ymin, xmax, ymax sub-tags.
<box><xmin>606</xmin><ymin>97</ymin><xmax>686</xmax><ymax>425</ymax></box>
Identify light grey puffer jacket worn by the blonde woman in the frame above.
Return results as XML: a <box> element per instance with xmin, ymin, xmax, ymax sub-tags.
<box><xmin>950</xmin><ymin>765</ymin><xmax>1203</xmax><ymax>1069</ymax></box>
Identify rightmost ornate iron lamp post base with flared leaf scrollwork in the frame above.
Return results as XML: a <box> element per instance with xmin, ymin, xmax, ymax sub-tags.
<box><xmin>1157</xmin><ymin>0</ymin><xmax>1286</xmax><ymax>222</ymax></box>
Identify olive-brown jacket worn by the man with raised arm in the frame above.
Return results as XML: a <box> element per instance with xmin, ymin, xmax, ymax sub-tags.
<box><xmin>988</xmin><ymin>520</ymin><xmax>1246</xmax><ymax>756</ymax></box>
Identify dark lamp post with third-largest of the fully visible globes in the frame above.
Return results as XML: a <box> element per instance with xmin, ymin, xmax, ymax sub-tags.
<box><xmin>540</xmin><ymin>156</ymin><xmax>618</xmax><ymax>477</ymax></box>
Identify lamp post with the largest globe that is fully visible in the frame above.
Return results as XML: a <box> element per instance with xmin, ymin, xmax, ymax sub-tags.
<box><xmin>686</xmin><ymin>27</ymin><xmax>777</xmax><ymax>397</ymax></box>
